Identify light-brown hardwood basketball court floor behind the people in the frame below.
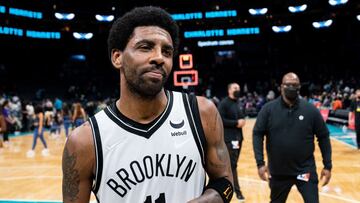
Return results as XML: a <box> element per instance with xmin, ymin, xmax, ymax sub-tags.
<box><xmin>0</xmin><ymin>120</ymin><xmax>360</xmax><ymax>203</ymax></box>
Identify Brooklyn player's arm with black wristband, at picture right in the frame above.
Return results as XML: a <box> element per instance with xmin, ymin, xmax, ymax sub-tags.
<box><xmin>190</xmin><ymin>97</ymin><xmax>233</xmax><ymax>203</ymax></box>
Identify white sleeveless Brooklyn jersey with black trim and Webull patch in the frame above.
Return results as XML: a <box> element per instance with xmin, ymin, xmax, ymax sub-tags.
<box><xmin>90</xmin><ymin>91</ymin><xmax>206</xmax><ymax>203</ymax></box>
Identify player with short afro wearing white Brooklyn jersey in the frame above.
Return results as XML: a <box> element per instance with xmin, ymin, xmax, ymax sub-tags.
<box><xmin>62</xmin><ymin>7</ymin><xmax>233</xmax><ymax>203</ymax></box>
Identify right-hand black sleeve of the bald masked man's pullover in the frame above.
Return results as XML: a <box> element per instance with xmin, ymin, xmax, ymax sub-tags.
<box><xmin>314</xmin><ymin>109</ymin><xmax>332</xmax><ymax>170</ymax></box>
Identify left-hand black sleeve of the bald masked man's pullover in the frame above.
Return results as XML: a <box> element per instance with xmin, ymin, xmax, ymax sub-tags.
<box><xmin>253</xmin><ymin>107</ymin><xmax>268</xmax><ymax>167</ymax></box>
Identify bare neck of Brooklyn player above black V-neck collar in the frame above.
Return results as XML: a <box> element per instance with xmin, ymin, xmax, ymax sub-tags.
<box><xmin>116</xmin><ymin>90</ymin><xmax>168</xmax><ymax>124</ymax></box>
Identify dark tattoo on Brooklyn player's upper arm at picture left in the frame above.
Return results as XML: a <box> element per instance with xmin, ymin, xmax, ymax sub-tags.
<box><xmin>62</xmin><ymin>147</ymin><xmax>80</xmax><ymax>201</ymax></box>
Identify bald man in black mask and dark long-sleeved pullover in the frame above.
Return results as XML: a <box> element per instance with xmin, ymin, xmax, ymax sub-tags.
<box><xmin>253</xmin><ymin>73</ymin><xmax>332</xmax><ymax>203</ymax></box>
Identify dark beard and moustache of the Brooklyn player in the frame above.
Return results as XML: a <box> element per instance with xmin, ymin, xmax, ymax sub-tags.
<box><xmin>124</xmin><ymin>66</ymin><xmax>168</xmax><ymax>100</ymax></box>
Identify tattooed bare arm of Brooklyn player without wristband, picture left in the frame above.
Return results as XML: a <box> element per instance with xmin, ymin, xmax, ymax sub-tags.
<box><xmin>62</xmin><ymin>122</ymin><xmax>95</xmax><ymax>203</ymax></box>
